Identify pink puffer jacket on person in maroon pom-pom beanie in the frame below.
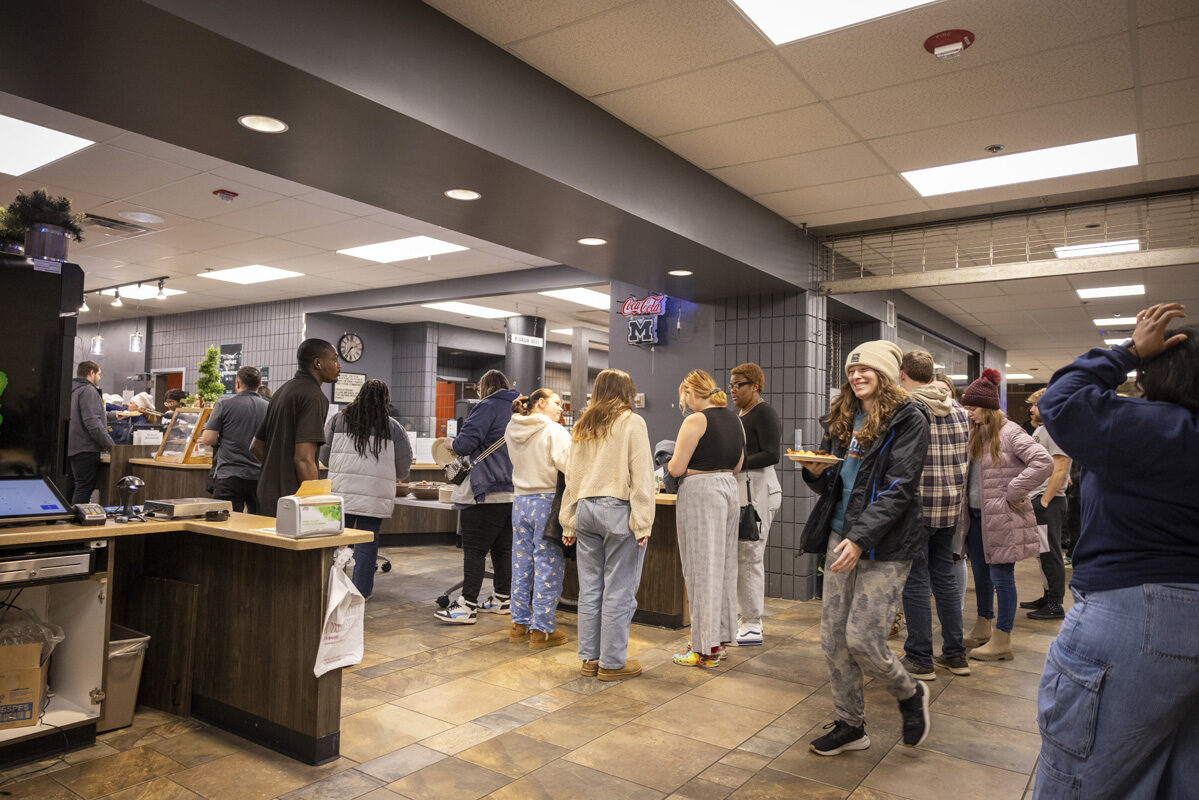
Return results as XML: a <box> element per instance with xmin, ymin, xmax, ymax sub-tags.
<box><xmin>962</xmin><ymin>420</ymin><xmax>1053</xmax><ymax>564</ymax></box>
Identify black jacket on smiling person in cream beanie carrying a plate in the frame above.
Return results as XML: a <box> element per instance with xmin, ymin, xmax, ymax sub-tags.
<box><xmin>802</xmin><ymin>399</ymin><xmax>929</xmax><ymax>561</ymax></box>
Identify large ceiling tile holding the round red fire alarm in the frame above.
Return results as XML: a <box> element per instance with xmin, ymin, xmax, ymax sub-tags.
<box><xmin>779</xmin><ymin>0</ymin><xmax>1128</xmax><ymax>100</ymax></box>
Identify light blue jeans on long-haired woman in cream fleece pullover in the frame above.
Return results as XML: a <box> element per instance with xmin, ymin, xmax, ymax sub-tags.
<box><xmin>574</xmin><ymin>498</ymin><xmax>645</xmax><ymax>669</ymax></box>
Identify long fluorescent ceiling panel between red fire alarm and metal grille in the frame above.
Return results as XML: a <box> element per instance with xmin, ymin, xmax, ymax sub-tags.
<box><xmin>900</xmin><ymin>133</ymin><xmax>1138</xmax><ymax>196</ymax></box>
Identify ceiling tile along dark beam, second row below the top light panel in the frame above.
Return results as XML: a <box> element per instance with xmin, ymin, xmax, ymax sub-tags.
<box><xmin>662</xmin><ymin>103</ymin><xmax>854</xmax><ymax>169</ymax></box>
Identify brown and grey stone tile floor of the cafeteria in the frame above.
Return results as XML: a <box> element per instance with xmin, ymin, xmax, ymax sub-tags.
<box><xmin>0</xmin><ymin>546</ymin><xmax>1059</xmax><ymax>800</ymax></box>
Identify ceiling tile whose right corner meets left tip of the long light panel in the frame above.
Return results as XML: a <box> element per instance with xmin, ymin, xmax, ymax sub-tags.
<box><xmin>712</xmin><ymin>144</ymin><xmax>891</xmax><ymax>196</ymax></box>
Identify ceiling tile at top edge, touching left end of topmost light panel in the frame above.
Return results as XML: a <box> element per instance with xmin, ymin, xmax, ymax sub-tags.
<box><xmin>511</xmin><ymin>0</ymin><xmax>767</xmax><ymax>97</ymax></box>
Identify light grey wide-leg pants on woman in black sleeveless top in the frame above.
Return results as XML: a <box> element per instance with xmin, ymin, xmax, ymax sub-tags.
<box><xmin>675</xmin><ymin>473</ymin><xmax>741</xmax><ymax>655</ymax></box>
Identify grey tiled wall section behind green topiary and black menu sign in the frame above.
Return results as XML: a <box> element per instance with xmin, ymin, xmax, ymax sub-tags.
<box><xmin>147</xmin><ymin>300</ymin><xmax>305</xmax><ymax>391</ymax></box>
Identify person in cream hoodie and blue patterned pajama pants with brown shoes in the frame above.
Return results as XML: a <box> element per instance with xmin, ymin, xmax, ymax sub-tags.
<box><xmin>504</xmin><ymin>389</ymin><xmax>571</xmax><ymax>650</ymax></box>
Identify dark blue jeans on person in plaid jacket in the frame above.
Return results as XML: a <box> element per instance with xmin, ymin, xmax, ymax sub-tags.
<box><xmin>903</xmin><ymin>525</ymin><xmax>966</xmax><ymax>667</ymax></box>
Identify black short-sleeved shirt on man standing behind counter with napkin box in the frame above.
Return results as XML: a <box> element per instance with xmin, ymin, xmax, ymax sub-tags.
<box><xmin>254</xmin><ymin>369</ymin><xmax>329</xmax><ymax>517</ymax></box>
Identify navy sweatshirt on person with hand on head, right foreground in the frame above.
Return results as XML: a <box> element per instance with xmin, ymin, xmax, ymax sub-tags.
<box><xmin>1037</xmin><ymin>345</ymin><xmax>1199</xmax><ymax>591</ymax></box>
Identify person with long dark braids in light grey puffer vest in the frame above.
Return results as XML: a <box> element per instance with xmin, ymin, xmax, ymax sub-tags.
<box><xmin>320</xmin><ymin>380</ymin><xmax>412</xmax><ymax>597</ymax></box>
